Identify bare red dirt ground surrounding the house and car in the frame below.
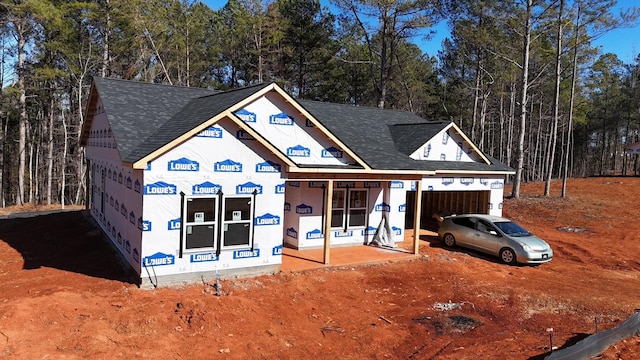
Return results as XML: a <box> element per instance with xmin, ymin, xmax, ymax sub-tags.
<box><xmin>0</xmin><ymin>177</ymin><xmax>640</xmax><ymax>359</ymax></box>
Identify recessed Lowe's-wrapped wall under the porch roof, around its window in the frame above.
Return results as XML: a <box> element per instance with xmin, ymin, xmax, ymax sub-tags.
<box><xmin>285</xmin><ymin>181</ymin><xmax>406</xmax><ymax>249</ymax></box>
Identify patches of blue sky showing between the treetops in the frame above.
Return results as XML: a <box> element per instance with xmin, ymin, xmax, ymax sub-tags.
<box><xmin>202</xmin><ymin>0</ymin><xmax>640</xmax><ymax>64</ymax></box>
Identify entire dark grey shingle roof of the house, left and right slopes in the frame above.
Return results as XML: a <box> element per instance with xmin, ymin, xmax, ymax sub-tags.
<box><xmin>94</xmin><ymin>78</ymin><xmax>513</xmax><ymax>171</ymax></box>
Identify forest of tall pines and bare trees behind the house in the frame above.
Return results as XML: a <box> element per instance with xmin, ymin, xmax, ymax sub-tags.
<box><xmin>0</xmin><ymin>0</ymin><xmax>640</xmax><ymax>207</ymax></box>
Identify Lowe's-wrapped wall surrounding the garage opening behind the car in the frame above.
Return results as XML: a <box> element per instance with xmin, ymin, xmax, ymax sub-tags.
<box><xmin>422</xmin><ymin>175</ymin><xmax>504</xmax><ymax>216</ymax></box>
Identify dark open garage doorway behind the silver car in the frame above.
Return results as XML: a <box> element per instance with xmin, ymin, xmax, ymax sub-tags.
<box><xmin>405</xmin><ymin>191</ymin><xmax>491</xmax><ymax>231</ymax></box>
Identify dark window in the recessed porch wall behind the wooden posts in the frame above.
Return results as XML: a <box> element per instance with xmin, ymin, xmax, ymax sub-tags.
<box><xmin>331</xmin><ymin>189</ymin><xmax>369</xmax><ymax>228</ymax></box>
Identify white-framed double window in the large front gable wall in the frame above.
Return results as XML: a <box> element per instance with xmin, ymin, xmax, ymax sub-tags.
<box><xmin>182</xmin><ymin>196</ymin><xmax>253</xmax><ymax>251</ymax></box>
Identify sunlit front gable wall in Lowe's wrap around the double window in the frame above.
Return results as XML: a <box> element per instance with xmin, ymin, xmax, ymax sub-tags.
<box><xmin>142</xmin><ymin>116</ymin><xmax>284</xmax><ymax>278</ymax></box>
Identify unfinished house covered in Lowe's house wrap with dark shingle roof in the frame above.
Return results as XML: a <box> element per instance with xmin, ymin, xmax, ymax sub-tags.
<box><xmin>81</xmin><ymin>79</ymin><xmax>512</xmax><ymax>285</ymax></box>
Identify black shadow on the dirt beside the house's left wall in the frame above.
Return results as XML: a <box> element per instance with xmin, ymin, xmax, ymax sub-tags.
<box><xmin>0</xmin><ymin>211</ymin><xmax>137</xmax><ymax>284</ymax></box>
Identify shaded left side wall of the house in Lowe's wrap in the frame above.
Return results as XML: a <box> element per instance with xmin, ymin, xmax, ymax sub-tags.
<box><xmin>86</xmin><ymin>98</ymin><xmax>142</xmax><ymax>273</ymax></box>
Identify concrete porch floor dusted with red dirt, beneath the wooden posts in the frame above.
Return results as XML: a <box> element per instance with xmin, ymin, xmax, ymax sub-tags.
<box><xmin>280</xmin><ymin>230</ymin><xmax>437</xmax><ymax>272</ymax></box>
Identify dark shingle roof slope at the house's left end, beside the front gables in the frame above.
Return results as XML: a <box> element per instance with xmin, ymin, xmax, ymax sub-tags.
<box><xmin>94</xmin><ymin>78</ymin><xmax>269</xmax><ymax>163</ymax></box>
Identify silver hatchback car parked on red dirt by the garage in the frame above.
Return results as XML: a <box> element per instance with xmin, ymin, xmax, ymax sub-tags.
<box><xmin>438</xmin><ymin>214</ymin><xmax>553</xmax><ymax>264</ymax></box>
